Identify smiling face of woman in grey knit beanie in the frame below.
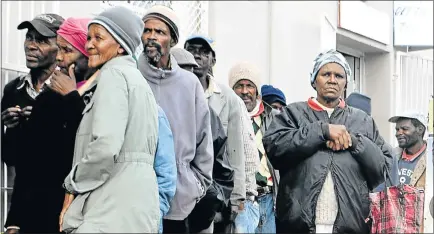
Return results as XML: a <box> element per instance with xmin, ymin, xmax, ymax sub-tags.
<box><xmin>86</xmin><ymin>24</ymin><xmax>124</xmax><ymax>68</ymax></box>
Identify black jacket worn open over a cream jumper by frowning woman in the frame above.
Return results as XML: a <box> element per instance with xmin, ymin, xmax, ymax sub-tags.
<box><xmin>263</xmin><ymin>100</ymin><xmax>392</xmax><ymax>233</ymax></box>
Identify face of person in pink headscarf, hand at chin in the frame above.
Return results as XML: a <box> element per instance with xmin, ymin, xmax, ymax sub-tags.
<box><xmin>56</xmin><ymin>35</ymin><xmax>88</xmax><ymax>81</ymax></box>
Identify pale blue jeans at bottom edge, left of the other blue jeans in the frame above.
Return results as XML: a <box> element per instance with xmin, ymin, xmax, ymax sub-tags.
<box><xmin>235</xmin><ymin>200</ymin><xmax>259</xmax><ymax>233</ymax></box>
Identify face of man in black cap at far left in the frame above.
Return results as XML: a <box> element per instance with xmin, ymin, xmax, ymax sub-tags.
<box><xmin>24</xmin><ymin>28</ymin><xmax>57</xmax><ymax>69</ymax></box>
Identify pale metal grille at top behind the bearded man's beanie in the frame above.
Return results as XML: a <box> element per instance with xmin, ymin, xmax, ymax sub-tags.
<box><xmin>98</xmin><ymin>1</ymin><xmax>208</xmax><ymax>45</ymax></box>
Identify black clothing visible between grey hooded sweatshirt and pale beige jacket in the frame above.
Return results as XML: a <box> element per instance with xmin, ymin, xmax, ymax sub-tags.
<box><xmin>188</xmin><ymin>108</ymin><xmax>234</xmax><ymax>233</ymax></box>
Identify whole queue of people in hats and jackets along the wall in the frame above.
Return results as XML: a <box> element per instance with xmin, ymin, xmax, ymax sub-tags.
<box><xmin>1</xmin><ymin>5</ymin><xmax>432</xmax><ymax>234</ymax></box>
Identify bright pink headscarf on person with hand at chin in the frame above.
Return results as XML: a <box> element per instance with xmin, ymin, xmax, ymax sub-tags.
<box><xmin>57</xmin><ymin>18</ymin><xmax>91</xmax><ymax>57</ymax></box>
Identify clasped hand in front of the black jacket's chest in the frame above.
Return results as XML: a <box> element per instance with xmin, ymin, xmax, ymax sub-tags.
<box><xmin>326</xmin><ymin>124</ymin><xmax>352</xmax><ymax>151</ymax></box>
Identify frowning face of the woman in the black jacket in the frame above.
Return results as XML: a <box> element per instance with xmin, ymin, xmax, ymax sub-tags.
<box><xmin>314</xmin><ymin>63</ymin><xmax>347</xmax><ymax>102</ymax></box>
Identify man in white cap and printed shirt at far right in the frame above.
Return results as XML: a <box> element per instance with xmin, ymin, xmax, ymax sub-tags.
<box><xmin>389</xmin><ymin>110</ymin><xmax>427</xmax><ymax>188</ymax></box>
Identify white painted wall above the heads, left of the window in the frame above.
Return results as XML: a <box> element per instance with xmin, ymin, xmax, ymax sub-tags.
<box><xmin>209</xmin><ymin>1</ymin><xmax>337</xmax><ymax>103</ymax></box>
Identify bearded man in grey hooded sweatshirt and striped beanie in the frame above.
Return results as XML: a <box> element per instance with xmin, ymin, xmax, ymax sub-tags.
<box><xmin>138</xmin><ymin>5</ymin><xmax>214</xmax><ymax>233</ymax></box>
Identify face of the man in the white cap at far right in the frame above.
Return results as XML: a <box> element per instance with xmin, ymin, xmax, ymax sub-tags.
<box><xmin>395</xmin><ymin>118</ymin><xmax>424</xmax><ymax>149</ymax></box>
